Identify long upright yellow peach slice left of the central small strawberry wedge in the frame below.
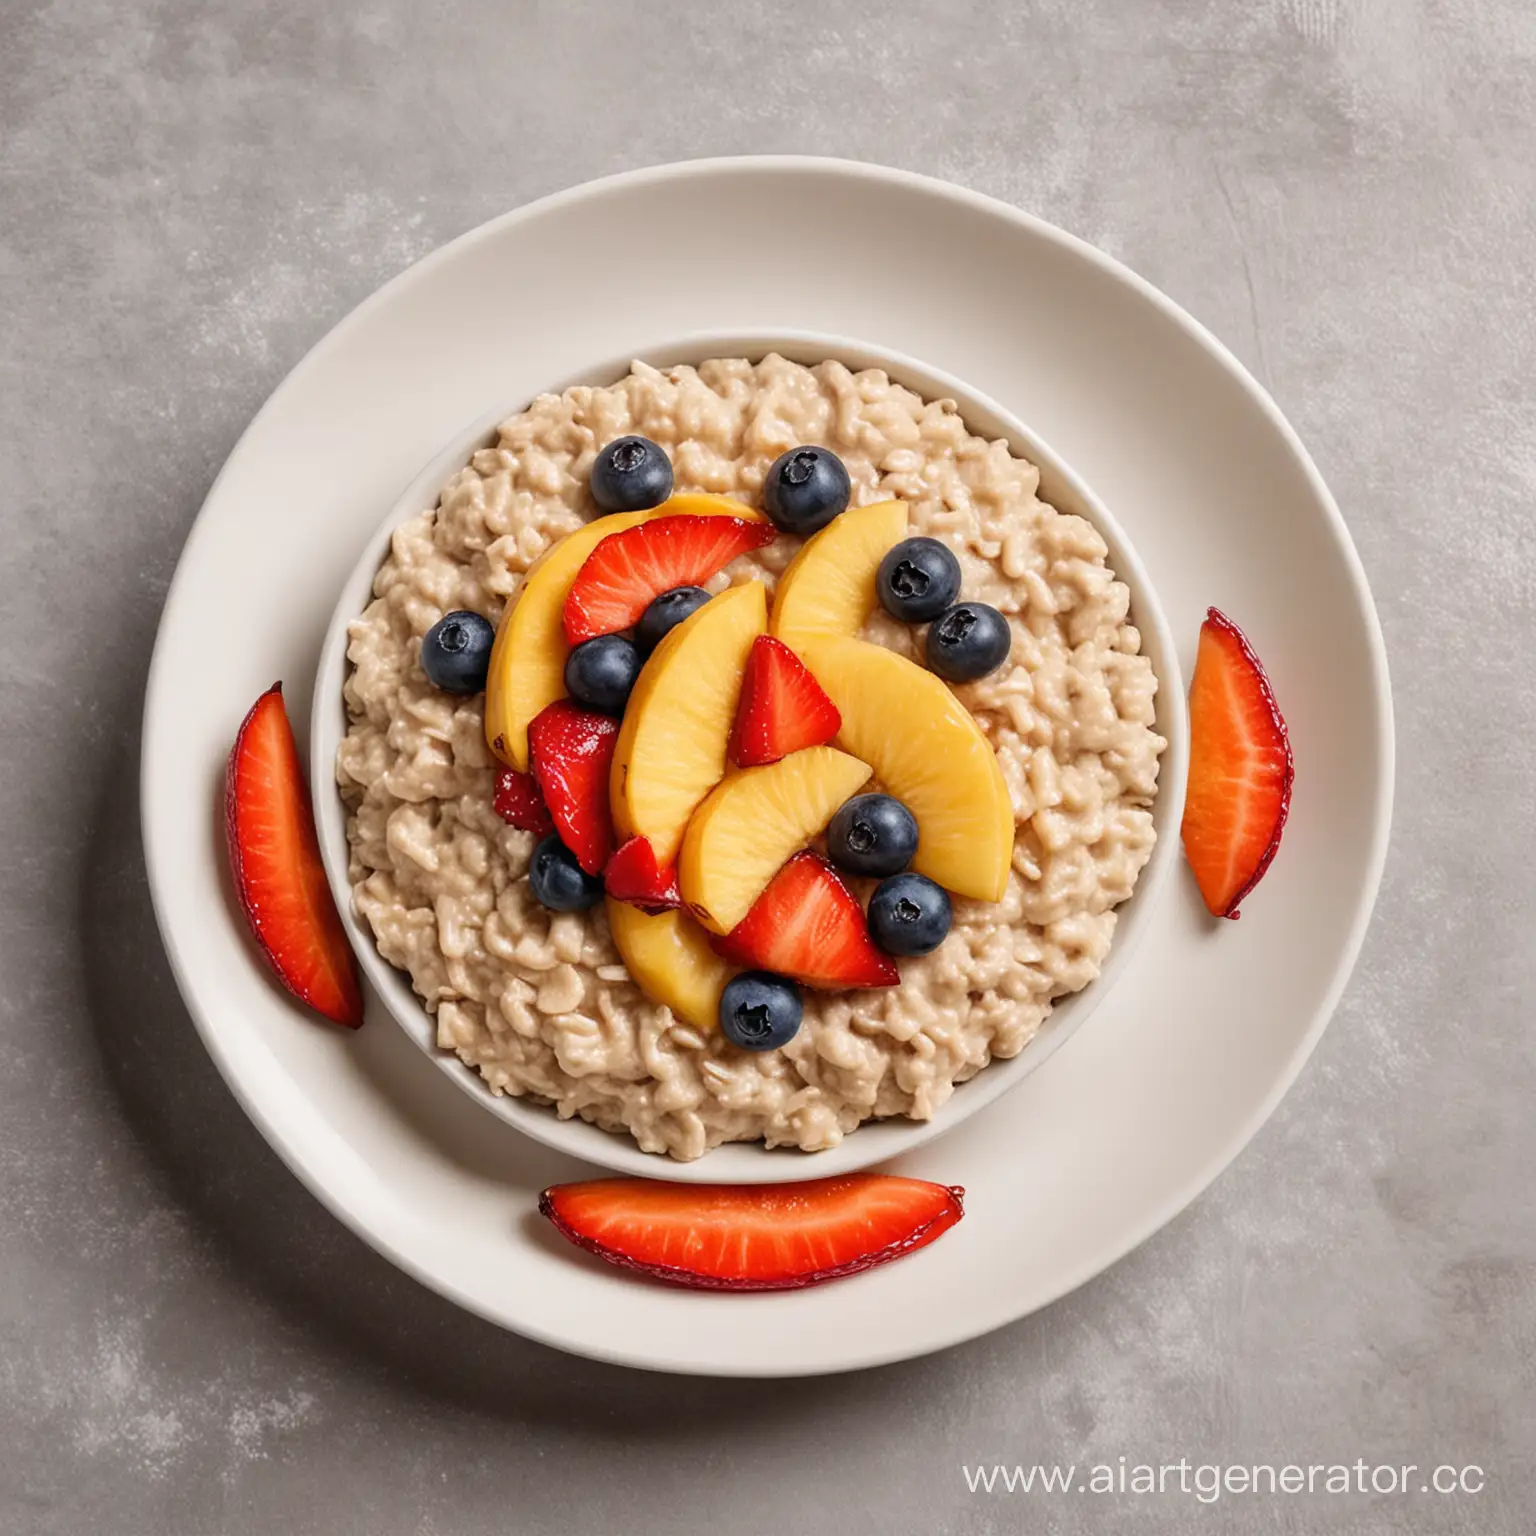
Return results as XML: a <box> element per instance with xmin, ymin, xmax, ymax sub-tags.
<box><xmin>613</xmin><ymin>581</ymin><xmax>768</xmax><ymax>863</ymax></box>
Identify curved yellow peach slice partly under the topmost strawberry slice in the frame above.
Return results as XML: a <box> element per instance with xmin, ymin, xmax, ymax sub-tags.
<box><xmin>485</xmin><ymin>492</ymin><xmax>763</xmax><ymax>770</ymax></box>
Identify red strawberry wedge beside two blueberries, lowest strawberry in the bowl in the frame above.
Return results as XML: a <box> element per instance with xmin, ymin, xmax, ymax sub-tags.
<box><xmin>711</xmin><ymin>849</ymin><xmax>902</xmax><ymax>992</ymax></box>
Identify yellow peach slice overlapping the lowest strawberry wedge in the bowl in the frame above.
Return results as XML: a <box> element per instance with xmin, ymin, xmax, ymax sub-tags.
<box><xmin>677</xmin><ymin>746</ymin><xmax>869</xmax><ymax>934</ymax></box>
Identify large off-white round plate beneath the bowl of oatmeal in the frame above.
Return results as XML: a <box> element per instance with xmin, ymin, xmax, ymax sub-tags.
<box><xmin>143</xmin><ymin>160</ymin><xmax>1392</xmax><ymax>1375</ymax></box>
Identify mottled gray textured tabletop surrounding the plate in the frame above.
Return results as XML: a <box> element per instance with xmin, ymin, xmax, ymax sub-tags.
<box><xmin>0</xmin><ymin>0</ymin><xmax>1536</xmax><ymax>1536</ymax></box>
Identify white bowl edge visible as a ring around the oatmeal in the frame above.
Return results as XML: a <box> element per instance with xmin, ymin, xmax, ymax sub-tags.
<box><xmin>310</xmin><ymin>330</ymin><xmax>1187</xmax><ymax>1184</ymax></box>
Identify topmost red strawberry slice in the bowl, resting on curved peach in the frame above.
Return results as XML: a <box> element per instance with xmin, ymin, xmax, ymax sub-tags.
<box><xmin>565</xmin><ymin>515</ymin><xmax>774</xmax><ymax>645</ymax></box>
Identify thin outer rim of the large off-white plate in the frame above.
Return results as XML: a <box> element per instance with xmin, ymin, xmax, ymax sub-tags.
<box><xmin>138</xmin><ymin>155</ymin><xmax>1396</xmax><ymax>1379</ymax></box>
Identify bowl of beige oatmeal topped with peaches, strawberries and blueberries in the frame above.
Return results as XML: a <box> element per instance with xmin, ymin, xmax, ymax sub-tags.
<box><xmin>312</xmin><ymin>336</ymin><xmax>1184</xmax><ymax>1183</ymax></box>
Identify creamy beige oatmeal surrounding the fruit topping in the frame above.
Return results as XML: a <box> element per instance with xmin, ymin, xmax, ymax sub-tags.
<box><xmin>338</xmin><ymin>356</ymin><xmax>1164</xmax><ymax>1158</ymax></box>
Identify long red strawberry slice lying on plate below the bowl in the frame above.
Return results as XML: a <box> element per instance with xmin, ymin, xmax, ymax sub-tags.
<box><xmin>539</xmin><ymin>1174</ymin><xmax>965</xmax><ymax>1290</ymax></box>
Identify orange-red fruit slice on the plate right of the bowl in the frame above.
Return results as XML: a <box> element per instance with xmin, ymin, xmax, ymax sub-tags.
<box><xmin>1183</xmin><ymin>608</ymin><xmax>1295</xmax><ymax>917</ymax></box>
